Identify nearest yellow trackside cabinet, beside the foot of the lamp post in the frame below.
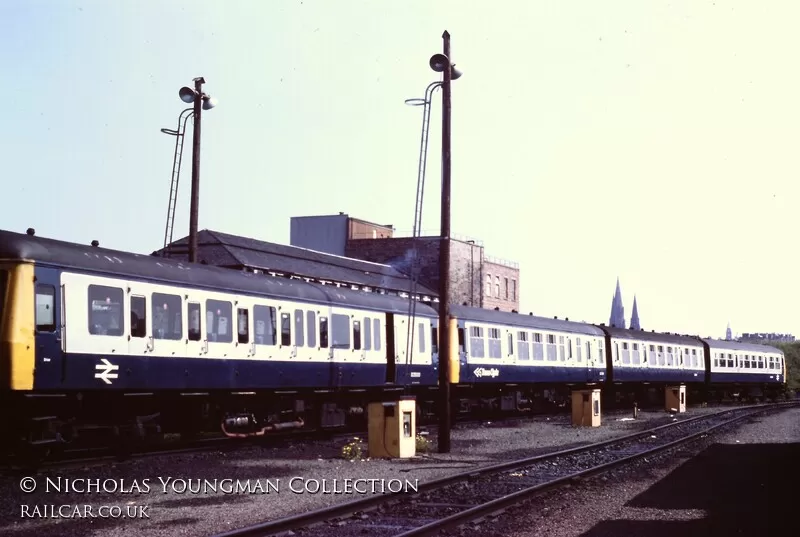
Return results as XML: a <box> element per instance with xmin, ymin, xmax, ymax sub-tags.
<box><xmin>367</xmin><ymin>397</ymin><xmax>417</xmax><ymax>459</ymax></box>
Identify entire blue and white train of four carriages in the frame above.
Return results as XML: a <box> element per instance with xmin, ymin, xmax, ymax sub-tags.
<box><xmin>0</xmin><ymin>229</ymin><xmax>786</xmax><ymax>451</ymax></box>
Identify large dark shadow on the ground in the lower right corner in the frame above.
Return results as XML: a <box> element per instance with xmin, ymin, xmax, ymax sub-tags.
<box><xmin>581</xmin><ymin>443</ymin><xmax>800</xmax><ymax>537</ymax></box>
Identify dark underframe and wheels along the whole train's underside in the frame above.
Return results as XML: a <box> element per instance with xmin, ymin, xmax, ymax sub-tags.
<box><xmin>0</xmin><ymin>383</ymin><xmax>784</xmax><ymax>453</ymax></box>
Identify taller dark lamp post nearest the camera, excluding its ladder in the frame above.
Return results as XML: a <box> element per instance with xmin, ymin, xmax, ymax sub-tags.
<box><xmin>429</xmin><ymin>30</ymin><xmax>461</xmax><ymax>453</ymax></box>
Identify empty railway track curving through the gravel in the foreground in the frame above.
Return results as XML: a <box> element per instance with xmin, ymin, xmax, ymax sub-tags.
<box><xmin>206</xmin><ymin>402</ymin><xmax>798</xmax><ymax>537</ymax></box>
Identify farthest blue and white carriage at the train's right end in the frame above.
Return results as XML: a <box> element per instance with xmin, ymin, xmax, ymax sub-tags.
<box><xmin>701</xmin><ymin>339</ymin><xmax>786</xmax><ymax>399</ymax></box>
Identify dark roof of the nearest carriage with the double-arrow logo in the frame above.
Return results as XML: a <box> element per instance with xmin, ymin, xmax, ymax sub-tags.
<box><xmin>0</xmin><ymin>230</ymin><xmax>436</xmax><ymax>316</ymax></box>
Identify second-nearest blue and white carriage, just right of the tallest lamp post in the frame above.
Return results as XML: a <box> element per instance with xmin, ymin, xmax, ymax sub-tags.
<box><xmin>450</xmin><ymin>306</ymin><xmax>606</xmax><ymax>410</ymax></box>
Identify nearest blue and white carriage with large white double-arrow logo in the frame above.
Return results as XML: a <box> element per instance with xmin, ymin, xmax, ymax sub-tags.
<box><xmin>0</xmin><ymin>231</ymin><xmax>438</xmax><ymax>446</ymax></box>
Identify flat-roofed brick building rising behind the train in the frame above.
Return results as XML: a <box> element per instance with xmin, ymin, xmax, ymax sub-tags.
<box><xmin>290</xmin><ymin>213</ymin><xmax>520</xmax><ymax>311</ymax></box>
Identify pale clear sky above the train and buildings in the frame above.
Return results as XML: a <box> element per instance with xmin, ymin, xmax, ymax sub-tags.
<box><xmin>0</xmin><ymin>0</ymin><xmax>800</xmax><ymax>337</ymax></box>
